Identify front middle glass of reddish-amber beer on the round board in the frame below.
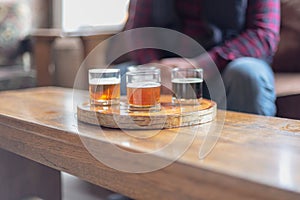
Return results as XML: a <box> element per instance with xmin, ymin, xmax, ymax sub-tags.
<box><xmin>126</xmin><ymin>69</ymin><xmax>161</xmax><ymax>111</ymax></box>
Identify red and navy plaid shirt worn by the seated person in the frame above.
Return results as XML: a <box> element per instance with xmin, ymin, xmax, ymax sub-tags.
<box><xmin>125</xmin><ymin>0</ymin><xmax>280</xmax><ymax>69</ymax></box>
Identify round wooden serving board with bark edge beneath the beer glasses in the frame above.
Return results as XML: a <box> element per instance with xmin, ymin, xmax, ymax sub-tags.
<box><xmin>77</xmin><ymin>96</ymin><xmax>217</xmax><ymax>129</ymax></box>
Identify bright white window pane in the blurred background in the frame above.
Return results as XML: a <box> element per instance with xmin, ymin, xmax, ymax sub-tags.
<box><xmin>62</xmin><ymin>0</ymin><xmax>129</xmax><ymax>32</ymax></box>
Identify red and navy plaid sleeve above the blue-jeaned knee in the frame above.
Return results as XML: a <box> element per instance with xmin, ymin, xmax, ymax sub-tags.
<box><xmin>209</xmin><ymin>0</ymin><xmax>280</xmax><ymax>69</ymax></box>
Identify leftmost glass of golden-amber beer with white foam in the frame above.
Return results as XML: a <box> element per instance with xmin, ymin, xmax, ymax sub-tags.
<box><xmin>89</xmin><ymin>69</ymin><xmax>121</xmax><ymax>105</ymax></box>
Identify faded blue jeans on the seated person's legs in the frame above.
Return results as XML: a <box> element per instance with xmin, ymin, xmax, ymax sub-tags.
<box><xmin>115</xmin><ymin>57</ymin><xmax>276</xmax><ymax>116</ymax></box>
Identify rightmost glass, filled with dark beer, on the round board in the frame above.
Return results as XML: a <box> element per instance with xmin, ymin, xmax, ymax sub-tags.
<box><xmin>171</xmin><ymin>68</ymin><xmax>203</xmax><ymax>104</ymax></box>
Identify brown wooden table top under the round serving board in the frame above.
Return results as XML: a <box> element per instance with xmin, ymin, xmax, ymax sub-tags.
<box><xmin>0</xmin><ymin>87</ymin><xmax>300</xmax><ymax>200</ymax></box>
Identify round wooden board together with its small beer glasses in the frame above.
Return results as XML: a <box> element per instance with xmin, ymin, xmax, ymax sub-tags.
<box><xmin>77</xmin><ymin>68</ymin><xmax>217</xmax><ymax>129</ymax></box>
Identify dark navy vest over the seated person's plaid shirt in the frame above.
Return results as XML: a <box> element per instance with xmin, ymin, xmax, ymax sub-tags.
<box><xmin>152</xmin><ymin>0</ymin><xmax>248</xmax><ymax>49</ymax></box>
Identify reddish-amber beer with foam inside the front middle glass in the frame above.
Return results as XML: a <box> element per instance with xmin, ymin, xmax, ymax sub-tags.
<box><xmin>127</xmin><ymin>83</ymin><xmax>160</xmax><ymax>107</ymax></box>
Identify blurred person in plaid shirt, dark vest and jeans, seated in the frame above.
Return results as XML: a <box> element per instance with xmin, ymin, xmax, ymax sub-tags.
<box><xmin>120</xmin><ymin>0</ymin><xmax>280</xmax><ymax>116</ymax></box>
